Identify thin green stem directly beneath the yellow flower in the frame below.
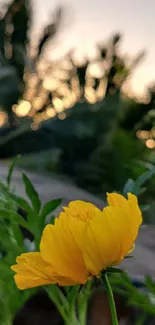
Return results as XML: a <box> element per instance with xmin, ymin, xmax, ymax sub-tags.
<box><xmin>102</xmin><ymin>273</ymin><xmax>118</xmax><ymax>325</ymax></box>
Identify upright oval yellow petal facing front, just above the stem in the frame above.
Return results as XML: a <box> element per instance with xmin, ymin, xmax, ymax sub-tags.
<box><xmin>83</xmin><ymin>207</ymin><xmax>124</xmax><ymax>275</ymax></box>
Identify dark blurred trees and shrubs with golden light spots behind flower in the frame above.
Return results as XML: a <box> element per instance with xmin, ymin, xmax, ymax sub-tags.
<box><xmin>0</xmin><ymin>0</ymin><xmax>155</xmax><ymax>222</ymax></box>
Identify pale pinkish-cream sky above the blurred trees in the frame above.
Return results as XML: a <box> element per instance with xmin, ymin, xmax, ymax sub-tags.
<box><xmin>0</xmin><ymin>0</ymin><xmax>155</xmax><ymax>94</ymax></box>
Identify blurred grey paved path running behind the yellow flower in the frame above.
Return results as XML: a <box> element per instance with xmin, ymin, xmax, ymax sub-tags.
<box><xmin>0</xmin><ymin>164</ymin><xmax>155</xmax><ymax>277</ymax></box>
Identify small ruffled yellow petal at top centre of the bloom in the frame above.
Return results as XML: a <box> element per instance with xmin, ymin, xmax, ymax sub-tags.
<box><xmin>60</xmin><ymin>200</ymin><xmax>100</xmax><ymax>222</ymax></box>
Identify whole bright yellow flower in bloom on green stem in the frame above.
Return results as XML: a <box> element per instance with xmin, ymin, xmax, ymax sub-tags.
<box><xmin>12</xmin><ymin>193</ymin><xmax>142</xmax><ymax>289</ymax></box>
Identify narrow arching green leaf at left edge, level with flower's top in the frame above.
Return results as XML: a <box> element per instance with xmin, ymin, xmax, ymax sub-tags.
<box><xmin>0</xmin><ymin>209</ymin><xmax>29</xmax><ymax>230</ymax></box>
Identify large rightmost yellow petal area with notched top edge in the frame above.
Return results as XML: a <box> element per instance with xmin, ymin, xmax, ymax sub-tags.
<box><xmin>83</xmin><ymin>194</ymin><xmax>142</xmax><ymax>275</ymax></box>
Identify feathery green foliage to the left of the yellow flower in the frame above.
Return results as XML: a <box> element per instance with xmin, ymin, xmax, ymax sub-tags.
<box><xmin>0</xmin><ymin>161</ymin><xmax>61</xmax><ymax>325</ymax></box>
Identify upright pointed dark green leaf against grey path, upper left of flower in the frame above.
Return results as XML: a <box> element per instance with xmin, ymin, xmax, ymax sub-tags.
<box><xmin>22</xmin><ymin>173</ymin><xmax>41</xmax><ymax>213</ymax></box>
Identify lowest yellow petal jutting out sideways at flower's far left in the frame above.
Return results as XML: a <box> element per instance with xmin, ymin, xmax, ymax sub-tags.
<box><xmin>11</xmin><ymin>253</ymin><xmax>55</xmax><ymax>290</ymax></box>
